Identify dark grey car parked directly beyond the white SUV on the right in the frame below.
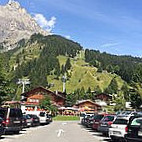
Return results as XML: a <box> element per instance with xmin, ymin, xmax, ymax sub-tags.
<box><xmin>98</xmin><ymin>115</ymin><xmax>116</xmax><ymax>135</ymax></box>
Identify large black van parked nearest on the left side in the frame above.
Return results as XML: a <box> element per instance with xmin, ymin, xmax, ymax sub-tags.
<box><xmin>0</xmin><ymin>108</ymin><xmax>23</xmax><ymax>133</ymax></box>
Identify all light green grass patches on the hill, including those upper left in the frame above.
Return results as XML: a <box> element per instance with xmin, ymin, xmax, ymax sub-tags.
<box><xmin>10</xmin><ymin>43</ymin><xmax>123</xmax><ymax>93</ymax></box>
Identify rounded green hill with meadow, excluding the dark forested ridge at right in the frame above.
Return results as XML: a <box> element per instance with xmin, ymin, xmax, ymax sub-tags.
<box><xmin>1</xmin><ymin>34</ymin><xmax>123</xmax><ymax>93</ymax></box>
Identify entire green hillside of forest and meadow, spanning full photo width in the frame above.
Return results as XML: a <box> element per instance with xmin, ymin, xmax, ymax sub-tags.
<box><xmin>0</xmin><ymin>34</ymin><xmax>142</xmax><ymax>110</ymax></box>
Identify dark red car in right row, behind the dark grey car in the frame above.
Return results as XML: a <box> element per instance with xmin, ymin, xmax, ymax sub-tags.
<box><xmin>92</xmin><ymin>114</ymin><xmax>106</xmax><ymax>131</ymax></box>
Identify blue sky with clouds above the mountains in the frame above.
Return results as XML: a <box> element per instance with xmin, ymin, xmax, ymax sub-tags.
<box><xmin>0</xmin><ymin>0</ymin><xmax>142</xmax><ymax>57</ymax></box>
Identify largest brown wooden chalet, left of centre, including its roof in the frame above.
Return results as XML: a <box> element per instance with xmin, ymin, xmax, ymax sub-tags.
<box><xmin>21</xmin><ymin>87</ymin><xmax>65</xmax><ymax>107</ymax></box>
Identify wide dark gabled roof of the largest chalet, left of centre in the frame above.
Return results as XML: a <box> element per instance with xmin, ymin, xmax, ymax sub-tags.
<box><xmin>21</xmin><ymin>87</ymin><xmax>65</xmax><ymax>99</ymax></box>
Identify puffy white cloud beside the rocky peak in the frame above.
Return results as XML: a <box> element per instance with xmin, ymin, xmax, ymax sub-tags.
<box><xmin>34</xmin><ymin>13</ymin><xmax>56</xmax><ymax>32</ymax></box>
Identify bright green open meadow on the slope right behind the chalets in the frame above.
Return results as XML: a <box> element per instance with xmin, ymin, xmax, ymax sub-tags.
<box><xmin>48</xmin><ymin>52</ymin><xmax>123</xmax><ymax>93</ymax></box>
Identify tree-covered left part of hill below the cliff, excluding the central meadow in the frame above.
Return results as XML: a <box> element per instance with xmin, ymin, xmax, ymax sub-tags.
<box><xmin>10</xmin><ymin>35</ymin><xmax>82</xmax><ymax>87</ymax></box>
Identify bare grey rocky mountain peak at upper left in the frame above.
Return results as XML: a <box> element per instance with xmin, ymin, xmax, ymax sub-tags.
<box><xmin>0</xmin><ymin>0</ymin><xmax>49</xmax><ymax>51</ymax></box>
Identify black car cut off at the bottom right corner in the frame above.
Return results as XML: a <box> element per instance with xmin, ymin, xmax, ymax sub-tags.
<box><xmin>126</xmin><ymin>116</ymin><xmax>142</xmax><ymax>142</ymax></box>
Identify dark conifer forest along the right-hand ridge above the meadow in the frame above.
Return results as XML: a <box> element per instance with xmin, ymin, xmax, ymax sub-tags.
<box><xmin>85</xmin><ymin>49</ymin><xmax>142</xmax><ymax>83</ymax></box>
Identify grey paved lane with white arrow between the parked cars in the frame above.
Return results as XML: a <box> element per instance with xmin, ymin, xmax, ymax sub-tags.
<box><xmin>0</xmin><ymin>121</ymin><xmax>108</xmax><ymax>142</ymax></box>
